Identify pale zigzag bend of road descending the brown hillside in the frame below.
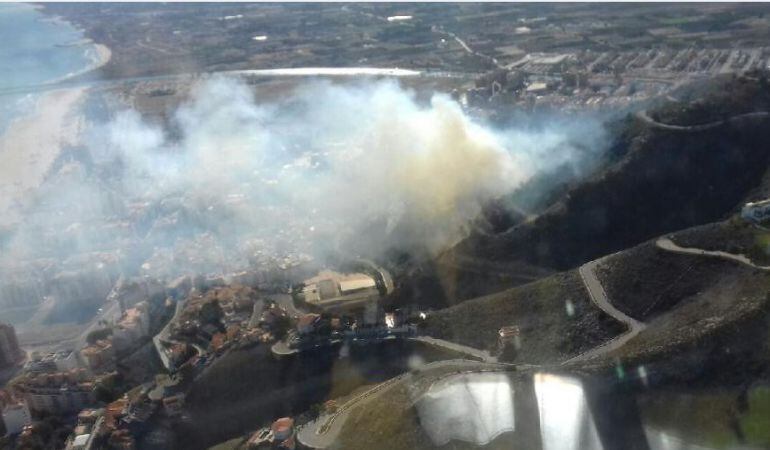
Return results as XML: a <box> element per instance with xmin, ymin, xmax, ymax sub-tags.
<box><xmin>563</xmin><ymin>258</ymin><xmax>646</xmax><ymax>364</ymax></box>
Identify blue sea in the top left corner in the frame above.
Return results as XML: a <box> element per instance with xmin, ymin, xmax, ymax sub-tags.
<box><xmin>0</xmin><ymin>3</ymin><xmax>93</xmax><ymax>133</ymax></box>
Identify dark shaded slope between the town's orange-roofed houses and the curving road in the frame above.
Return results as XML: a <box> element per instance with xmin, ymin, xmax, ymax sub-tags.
<box><xmin>178</xmin><ymin>341</ymin><xmax>456</xmax><ymax>449</ymax></box>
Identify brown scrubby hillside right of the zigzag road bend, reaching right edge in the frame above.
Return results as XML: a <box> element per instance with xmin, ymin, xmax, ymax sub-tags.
<box><xmin>578</xmin><ymin>217</ymin><xmax>770</xmax><ymax>384</ymax></box>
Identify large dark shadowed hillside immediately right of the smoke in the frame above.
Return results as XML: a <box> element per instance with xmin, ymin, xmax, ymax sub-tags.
<box><xmin>439</xmin><ymin>74</ymin><xmax>770</xmax><ymax>292</ymax></box>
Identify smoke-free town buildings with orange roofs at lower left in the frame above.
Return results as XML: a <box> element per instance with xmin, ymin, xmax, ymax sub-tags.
<box><xmin>0</xmin><ymin>248</ymin><xmax>438</xmax><ymax>450</ymax></box>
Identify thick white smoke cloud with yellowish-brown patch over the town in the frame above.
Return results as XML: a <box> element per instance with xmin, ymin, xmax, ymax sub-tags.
<box><xmin>4</xmin><ymin>78</ymin><xmax>603</xmax><ymax>280</ymax></box>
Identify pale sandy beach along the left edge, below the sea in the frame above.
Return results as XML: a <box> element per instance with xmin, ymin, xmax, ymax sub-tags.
<box><xmin>0</xmin><ymin>88</ymin><xmax>86</xmax><ymax>226</ymax></box>
